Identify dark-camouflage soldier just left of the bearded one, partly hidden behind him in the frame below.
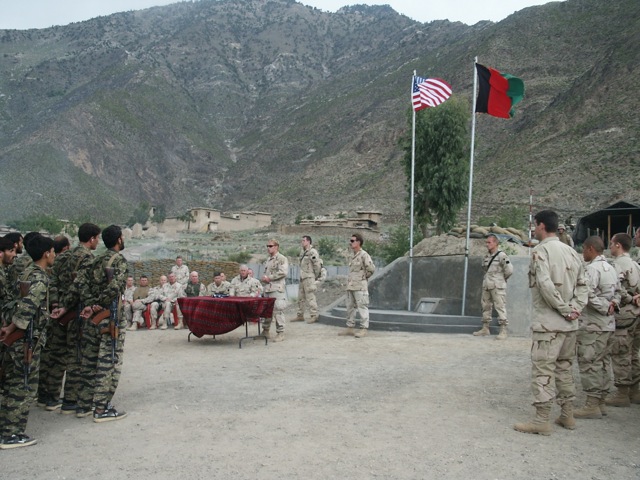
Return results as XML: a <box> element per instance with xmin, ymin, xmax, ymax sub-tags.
<box><xmin>43</xmin><ymin>223</ymin><xmax>101</xmax><ymax>415</ymax></box>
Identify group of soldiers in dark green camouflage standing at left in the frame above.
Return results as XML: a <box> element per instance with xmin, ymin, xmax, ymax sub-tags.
<box><xmin>0</xmin><ymin>223</ymin><xmax>127</xmax><ymax>449</ymax></box>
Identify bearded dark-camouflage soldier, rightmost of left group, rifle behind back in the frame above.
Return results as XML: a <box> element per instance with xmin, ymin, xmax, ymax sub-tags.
<box><xmin>66</xmin><ymin>225</ymin><xmax>127</xmax><ymax>423</ymax></box>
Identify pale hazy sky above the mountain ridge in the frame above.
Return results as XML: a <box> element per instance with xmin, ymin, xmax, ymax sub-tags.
<box><xmin>0</xmin><ymin>0</ymin><xmax>560</xmax><ymax>29</ymax></box>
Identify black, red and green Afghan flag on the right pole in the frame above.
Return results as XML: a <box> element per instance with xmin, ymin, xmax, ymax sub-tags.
<box><xmin>476</xmin><ymin>63</ymin><xmax>524</xmax><ymax>118</ymax></box>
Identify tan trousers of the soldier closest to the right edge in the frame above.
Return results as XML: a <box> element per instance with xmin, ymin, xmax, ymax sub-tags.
<box><xmin>609</xmin><ymin>319</ymin><xmax>640</xmax><ymax>386</ymax></box>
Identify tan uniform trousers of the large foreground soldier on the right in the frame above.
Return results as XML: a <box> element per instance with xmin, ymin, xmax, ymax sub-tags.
<box><xmin>531</xmin><ymin>331</ymin><xmax>577</xmax><ymax>405</ymax></box>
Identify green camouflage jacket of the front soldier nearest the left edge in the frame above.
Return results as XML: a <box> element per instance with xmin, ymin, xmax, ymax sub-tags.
<box><xmin>12</xmin><ymin>263</ymin><xmax>49</xmax><ymax>340</ymax></box>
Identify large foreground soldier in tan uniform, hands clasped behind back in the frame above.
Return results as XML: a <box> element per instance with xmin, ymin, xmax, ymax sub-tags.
<box><xmin>513</xmin><ymin>210</ymin><xmax>589</xmax><ymax>435</ymax></box>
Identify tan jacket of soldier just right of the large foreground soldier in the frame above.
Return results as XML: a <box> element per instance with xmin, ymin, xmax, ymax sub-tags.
<box><xmin>578</xmin><ymin>255</ymin><xmax>620</xmax><ymax>332</ymax></box>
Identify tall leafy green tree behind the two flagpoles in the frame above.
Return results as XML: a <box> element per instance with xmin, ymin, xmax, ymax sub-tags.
<box><xmin>403</xmin><ymin>96</ymin><xmax>470</xmax><ymax>236</ymax></box>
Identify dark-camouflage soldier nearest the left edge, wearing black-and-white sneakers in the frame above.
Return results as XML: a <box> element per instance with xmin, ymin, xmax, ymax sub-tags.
<box><xmin>0</xmin><ymin>235</ymin><xmax>56</xmax><ymax>449</ymax></box>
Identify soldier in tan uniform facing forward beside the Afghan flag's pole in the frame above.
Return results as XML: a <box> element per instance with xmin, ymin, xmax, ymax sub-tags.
<box><xmin>473</xmin><ymin>234</ymin><xmax>513</xmax><ymax>340</ymax></box>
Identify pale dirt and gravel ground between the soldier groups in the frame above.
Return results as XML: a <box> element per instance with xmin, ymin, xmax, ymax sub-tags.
<box><xmin>5</xmin><ymin>284</ymin><xmax>640</xmax><ymax>480</ymax></box>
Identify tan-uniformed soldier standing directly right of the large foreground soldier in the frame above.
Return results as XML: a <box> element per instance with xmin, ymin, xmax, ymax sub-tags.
<box><xmin>573</xmin><ymin>236</ymin><xmax>620</xmax><ymax>418</ymax></box>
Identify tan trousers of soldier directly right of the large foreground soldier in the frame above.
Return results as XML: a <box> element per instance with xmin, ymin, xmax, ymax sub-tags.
<box><xmin>577</xmin><ymin>330</ymin><xmax>613</xmax><ymax>398</ymax></box>
